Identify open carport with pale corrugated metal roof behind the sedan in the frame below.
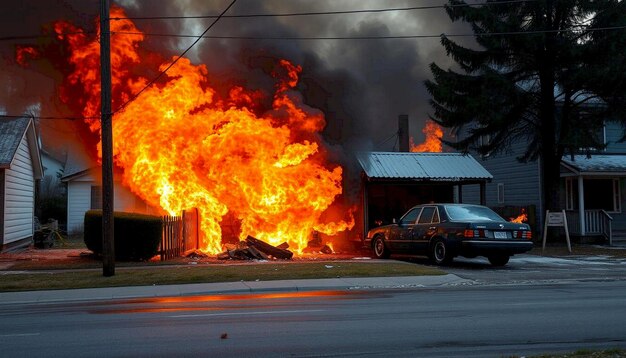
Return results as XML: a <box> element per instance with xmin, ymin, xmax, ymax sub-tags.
<box><xmin>356</xmin><ymin>152</ymin><xmax>493</xmax><ymax>235</ymax></box>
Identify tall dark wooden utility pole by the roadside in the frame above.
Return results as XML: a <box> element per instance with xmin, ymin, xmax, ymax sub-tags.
<box><xmin>100</xmin><ymin>0</ymin><xmax>115</xmax><ymax>277</ymax></box>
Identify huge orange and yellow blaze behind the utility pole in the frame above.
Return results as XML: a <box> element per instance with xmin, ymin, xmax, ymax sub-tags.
<box><xmin>50</xmin><ymin>8</ymin><xmax>354</xmax><ymax>254</ymax></box>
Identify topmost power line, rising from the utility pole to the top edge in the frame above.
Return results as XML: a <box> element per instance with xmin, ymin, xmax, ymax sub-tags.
<box><xmin>111</xmin><ymin>0</ymin><xmax>537</xmax><ymax>20</ymax></box>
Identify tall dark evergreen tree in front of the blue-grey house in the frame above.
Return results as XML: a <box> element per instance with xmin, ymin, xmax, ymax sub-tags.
<box><xmin>426</xmin><ymin>0</ymin><xmax>626</xmax><ymax>210</ymax></box>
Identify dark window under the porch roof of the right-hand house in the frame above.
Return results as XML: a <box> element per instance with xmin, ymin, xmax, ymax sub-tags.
<box><xmin>583</xmin><ymin>179</ymin><xmax>622</xmax><ymax>212</ymax></box>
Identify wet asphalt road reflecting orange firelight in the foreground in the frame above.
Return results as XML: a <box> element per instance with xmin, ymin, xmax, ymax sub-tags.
<box><xmin>0</xmin><ymin>278</ymin><xmax>626</xmax><ymax>357</ymax></box>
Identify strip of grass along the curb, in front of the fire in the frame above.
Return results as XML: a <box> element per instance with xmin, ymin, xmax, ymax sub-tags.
<box><xmin>0</xmin><ymin>261</ymin><xmax>445</xmax><ymax>292</ymax></box>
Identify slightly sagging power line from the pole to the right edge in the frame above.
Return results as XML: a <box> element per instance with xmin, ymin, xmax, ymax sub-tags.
<box><xmin>112</xmin><ymin>25</ymin><xmax>626</xmax><ymax>41</ymax></box>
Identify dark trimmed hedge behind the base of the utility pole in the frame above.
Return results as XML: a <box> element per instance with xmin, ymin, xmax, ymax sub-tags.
<box><xmin>84</xmin><ymin>210</ymin><xmax>163</xmax><ymax>261</ymax></box>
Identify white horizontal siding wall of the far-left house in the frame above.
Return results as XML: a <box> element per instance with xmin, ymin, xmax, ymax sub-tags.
<box><xmin>4</xmin><ymin>137</ymin><xmax>35</xmax><ymax>245</ymax></box>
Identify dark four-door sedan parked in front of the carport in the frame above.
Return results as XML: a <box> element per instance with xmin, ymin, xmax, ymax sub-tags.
<box><xmin>365</xmin><ymin>204</ymin><xmax>533</xmax><ymax>266</ymax></box>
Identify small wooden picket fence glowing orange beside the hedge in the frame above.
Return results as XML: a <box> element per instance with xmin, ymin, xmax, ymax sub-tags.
<box><xmin>159</xmin><ymin>209</ymin><xmax>199</xmax><ymax>261</ymax></box>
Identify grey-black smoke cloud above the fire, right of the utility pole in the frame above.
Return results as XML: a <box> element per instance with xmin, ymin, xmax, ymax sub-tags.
<box><xmin>113</xmin><ymin>0</ymin><xmax>467</xmax><ymax>151</ymax></box>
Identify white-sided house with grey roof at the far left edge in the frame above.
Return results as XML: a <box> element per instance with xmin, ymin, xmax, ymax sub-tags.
<box><xmin>0</xmin><ymin>118</ymin><xmax>43</xmax><ymax>250</ymax></box>
